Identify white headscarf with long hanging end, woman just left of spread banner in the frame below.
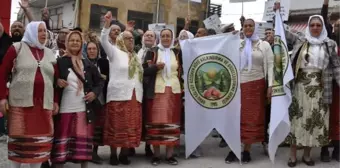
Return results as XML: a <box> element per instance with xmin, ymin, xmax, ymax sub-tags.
<box><xmin>158</xmin><ymin>29</ymin><xmax>175</xmax><ymax>79</ymax></box>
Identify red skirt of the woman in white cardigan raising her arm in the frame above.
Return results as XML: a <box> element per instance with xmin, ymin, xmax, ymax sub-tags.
<box><xmin>103</xmin><ymin>91</ymin><xmax>142</xmax><ymax>148</ymax></box>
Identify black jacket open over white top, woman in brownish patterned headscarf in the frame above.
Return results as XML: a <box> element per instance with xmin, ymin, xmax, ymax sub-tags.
<box><xmin>57</xmin><ymin>56</ymin><xmax>104</xmax><ymax>123</ymax></box>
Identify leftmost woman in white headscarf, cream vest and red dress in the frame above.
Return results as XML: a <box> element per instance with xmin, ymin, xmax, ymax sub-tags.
<box><xmin>0</xmin><ymin>22</ymin><xmax>58</xmax><ymax>168</ymax></box>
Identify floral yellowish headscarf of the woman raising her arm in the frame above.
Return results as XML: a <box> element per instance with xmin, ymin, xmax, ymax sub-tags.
<box><xmin>116</xmin><ymin>32</ymin><xmax>143</xmax><ymax>82</ymax></box>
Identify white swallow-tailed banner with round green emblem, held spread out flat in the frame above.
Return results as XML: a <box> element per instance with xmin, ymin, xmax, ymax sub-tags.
<box><xmin>180</xmin><ymin>33</ymin><xmax>241</xmax><ymax>158</ymax></box>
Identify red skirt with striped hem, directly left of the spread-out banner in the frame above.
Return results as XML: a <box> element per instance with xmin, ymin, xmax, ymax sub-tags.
<box><xmin>146</xmin><ymin>87</ymin><xmax>182</xmax><ymax>146</ymax></box>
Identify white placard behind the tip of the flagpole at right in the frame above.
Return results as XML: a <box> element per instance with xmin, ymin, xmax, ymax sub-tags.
<box><xmin>262</xmin><ymin>0</ymin><xmax>290</xmax><ymax>21</ymax></box>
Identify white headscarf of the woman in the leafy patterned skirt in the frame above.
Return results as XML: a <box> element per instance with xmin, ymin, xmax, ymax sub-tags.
<box><xmin>305</xmin><ymin>15</ymin><xmax>328</xmax><ymax>44</ymax></box>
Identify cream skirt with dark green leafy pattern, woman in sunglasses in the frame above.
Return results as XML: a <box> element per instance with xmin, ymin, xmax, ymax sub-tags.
<box><xmin>286</xmin><ymin>69</ymin><xmax>329</xmax><ymax>147</ymax></box>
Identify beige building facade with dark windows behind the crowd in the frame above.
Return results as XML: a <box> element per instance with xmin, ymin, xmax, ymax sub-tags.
<box><xmin>79</xmin><ymin>0</ymin><xmax>209</xmax><ymax>34</ymax></box>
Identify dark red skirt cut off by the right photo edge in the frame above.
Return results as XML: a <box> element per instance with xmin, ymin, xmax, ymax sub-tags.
<box><xmin>329</xmin><ymin>82</ymin><xmax>340</xmax><ymax>141</ymax></box>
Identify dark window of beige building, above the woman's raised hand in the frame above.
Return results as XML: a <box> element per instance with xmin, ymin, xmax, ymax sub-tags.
<box><xmin>89</xmin><ymin>4</ymin><xmax>118</xmax><ymax>30</ymax></box>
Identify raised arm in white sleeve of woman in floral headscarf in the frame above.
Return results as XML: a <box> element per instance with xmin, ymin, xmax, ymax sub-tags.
<box><xmin>100</xmin><ymin>11</ymin><xmax>116</xmax><ymax>61</ymax></box>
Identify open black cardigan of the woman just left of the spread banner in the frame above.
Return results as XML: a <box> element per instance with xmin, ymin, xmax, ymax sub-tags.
<box><xmin>143</xmin><ymin>47</ymin><xmax>184</xmax><ymax>99</ymax></box>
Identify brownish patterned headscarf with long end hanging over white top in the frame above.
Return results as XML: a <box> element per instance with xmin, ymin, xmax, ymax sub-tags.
<box><xmin>65</xmin><ymin>31</ymin><xmax>84</xmax><ymax>95</ymax></box>
